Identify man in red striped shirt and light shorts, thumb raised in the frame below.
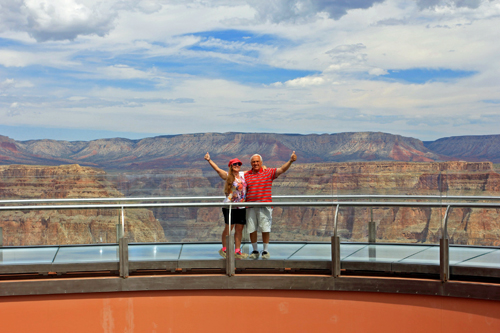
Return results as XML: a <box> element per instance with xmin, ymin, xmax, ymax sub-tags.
<box><xmin>245</xmin><ymin>151</ymin><xmax>297</xmax><ymax>259</ymax></box>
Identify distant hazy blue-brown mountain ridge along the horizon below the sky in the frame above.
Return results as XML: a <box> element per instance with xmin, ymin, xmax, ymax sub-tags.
<box><xmin>0</xmin><ymin>132</ymin><xmax>500</xmax><ymax>171</ymax></box>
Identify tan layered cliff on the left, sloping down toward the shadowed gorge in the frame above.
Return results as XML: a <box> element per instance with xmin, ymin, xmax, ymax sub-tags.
<box><xmin>0</xmin><ymin>165</ymin><xmax>166</xmax><ymax>246</ymax></box>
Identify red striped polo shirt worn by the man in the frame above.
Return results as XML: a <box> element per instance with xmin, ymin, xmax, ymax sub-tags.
<box><xmin>245</xmin><ymin>168</ymin><xmax>276</xmax><ymax>202</ymax></box>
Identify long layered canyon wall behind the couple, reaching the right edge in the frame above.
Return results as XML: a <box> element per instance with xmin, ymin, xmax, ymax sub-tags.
<box><xmin>112</xmin><ymin>162</ymin><xmax>500</xmax><ymax>246</ymax></box>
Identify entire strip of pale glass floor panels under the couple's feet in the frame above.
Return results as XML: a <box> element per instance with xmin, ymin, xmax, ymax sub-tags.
<box><xmin>0</xmin><ymin>243</ymin><xmax>500</xmax><ymax>269</ymax></box>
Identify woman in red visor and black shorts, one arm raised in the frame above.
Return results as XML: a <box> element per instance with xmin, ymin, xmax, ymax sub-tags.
<box><xmin>205</xmin><ymin>153</ymin><xmax>248</xmax><ymax>259</ymax></box>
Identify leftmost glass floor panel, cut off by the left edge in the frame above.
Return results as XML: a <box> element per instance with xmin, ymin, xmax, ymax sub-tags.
<box><xmin>0</xmin><ymin>247</ymin><xmax>58</xmax><ymax>265</ymax></box>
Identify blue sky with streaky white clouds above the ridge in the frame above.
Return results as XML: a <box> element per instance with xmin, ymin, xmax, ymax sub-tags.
<box><xmin>0</xmin><ymin>0</ymin><xmax>500</xmax><ymax>141</ymax></box>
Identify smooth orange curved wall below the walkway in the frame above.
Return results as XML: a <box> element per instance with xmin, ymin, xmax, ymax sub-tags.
<box><xmin>0</xmin><ymin>290</ymin><xmax>500</xmax><ymax>333</ymax></box>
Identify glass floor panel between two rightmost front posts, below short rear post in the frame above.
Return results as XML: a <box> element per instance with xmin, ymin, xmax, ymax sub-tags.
<box><xmin>342</xmin><ymin>245</ymin><xmax>428</xmax><ymax>262</ymax></box>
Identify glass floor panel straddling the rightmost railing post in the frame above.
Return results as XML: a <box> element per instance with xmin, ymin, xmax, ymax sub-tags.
<box><xmin>399</xmin><ymin>246</ymin><xmax>494</xmax><ymax>265</ymax></box>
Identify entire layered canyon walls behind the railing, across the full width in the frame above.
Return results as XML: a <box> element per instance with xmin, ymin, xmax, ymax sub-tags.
<box><xmin>0</xmin><ymin>157</ymin><xmax>500</xmax><ymax>246</ymax></box>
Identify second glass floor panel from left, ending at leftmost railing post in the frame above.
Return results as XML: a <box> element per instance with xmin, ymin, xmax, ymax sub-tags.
<box><xmin>54</xmin><ymin>245</ymin><xmax>119</xmax><ymax>264</ymax></box>
